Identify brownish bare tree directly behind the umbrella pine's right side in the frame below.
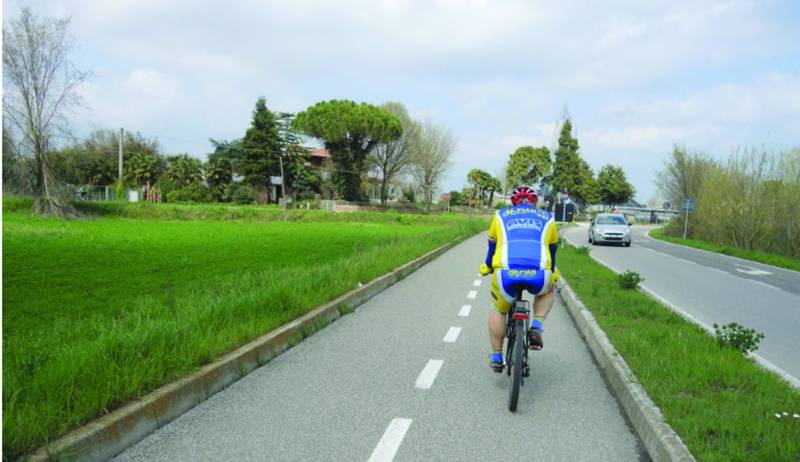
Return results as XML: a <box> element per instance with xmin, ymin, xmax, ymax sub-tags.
<box><xmin>369</xmin><ymin>102</ymin><xmax>419</xmax><ymax>204</ymax></box>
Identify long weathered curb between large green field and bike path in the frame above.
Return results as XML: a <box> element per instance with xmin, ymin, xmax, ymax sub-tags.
<box><xmin>29</xmin><ymin>236</ymin><xmax>468</xmax><ymax>462</ymax></box>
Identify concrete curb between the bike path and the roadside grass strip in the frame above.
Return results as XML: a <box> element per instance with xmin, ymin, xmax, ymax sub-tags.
<box><xmin>556</xmin><ymin>277</ymin><xmax>695</xmax><ymax>462</ymax></box>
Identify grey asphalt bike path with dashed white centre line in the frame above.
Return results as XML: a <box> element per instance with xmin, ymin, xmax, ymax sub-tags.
<box><xmin>115</xmin><ymin>235</ymin><xmax>647</xmax><ymax>461</ymax></box>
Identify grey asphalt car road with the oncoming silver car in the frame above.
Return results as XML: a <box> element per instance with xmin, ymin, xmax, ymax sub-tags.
<box><xmin>565</xmin><ymin>225</ymin><xmax>800</xmax><ymax>383</ymax></box>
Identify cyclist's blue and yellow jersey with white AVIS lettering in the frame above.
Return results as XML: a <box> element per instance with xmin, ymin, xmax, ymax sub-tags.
<box><xmin>489</xmin><ymin>204</ymin><xmax>558</xmax><ymax>269</ymax></box>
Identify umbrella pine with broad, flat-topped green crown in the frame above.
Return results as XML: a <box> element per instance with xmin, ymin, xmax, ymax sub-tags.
<box><xmin>294</xmin><ymin>100</ymin><xmax>403</xmax><ymax>200</ymax></box>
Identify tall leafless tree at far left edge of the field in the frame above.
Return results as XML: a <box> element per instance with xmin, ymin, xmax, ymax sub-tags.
<box><xmin>3</xmin><ymin>8</ymin><xmax>88</xmax><ymax>216</ymax></box>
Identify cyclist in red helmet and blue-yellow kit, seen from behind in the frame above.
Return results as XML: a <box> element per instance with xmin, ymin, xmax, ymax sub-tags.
<box><xmin>480</xmin><ymin>186</ymin><xmax>559</xmax><ymax>373</ymax></box>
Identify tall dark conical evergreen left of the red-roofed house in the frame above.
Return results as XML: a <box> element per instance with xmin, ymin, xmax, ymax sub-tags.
<box><xmin>239</xmin><ymin>97</ymin><xmax>282</xmax><ymax>203</ymax></box>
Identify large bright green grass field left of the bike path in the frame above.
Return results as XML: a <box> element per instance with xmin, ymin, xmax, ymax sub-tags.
<box><xmin>3</xmin><ymin>200</ymin><xmax>488</xmax><ymax>458</ymax></box>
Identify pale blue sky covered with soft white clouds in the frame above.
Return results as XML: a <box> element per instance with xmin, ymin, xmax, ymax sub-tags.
<box><xmin>3</xmin><ymin>0</ymin><xmax>800</xmax><ymax>202</ymax></box>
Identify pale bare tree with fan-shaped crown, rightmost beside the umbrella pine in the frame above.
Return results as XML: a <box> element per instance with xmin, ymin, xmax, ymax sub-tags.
<box><xmin>411</xmin><ymin>122</ymin><xmax>457</xmax><ymax>210</ymax></box>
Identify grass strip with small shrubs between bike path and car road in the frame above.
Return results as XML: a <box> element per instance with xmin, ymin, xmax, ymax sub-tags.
<box><xmin>558</xmin><ymin>246</ymin><xmax>800</xmax><ymax>461</ymax></box>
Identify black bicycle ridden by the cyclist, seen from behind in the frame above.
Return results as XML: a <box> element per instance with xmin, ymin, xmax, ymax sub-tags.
<box><xmin>506</xmin><ymin>290</ymin><xmax>531</xmax><ymax>412</ymax></box>
